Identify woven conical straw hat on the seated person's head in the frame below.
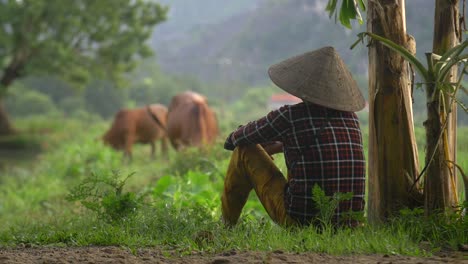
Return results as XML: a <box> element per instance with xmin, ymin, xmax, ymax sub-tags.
<box><xmin>268</xmin><ymin>47</ymin><xmax>366</xmax><ymax>112</ymax></box>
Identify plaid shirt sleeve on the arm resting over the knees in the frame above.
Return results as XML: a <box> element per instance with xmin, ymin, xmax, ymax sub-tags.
<box><xmin>225</xmin><ymin>106</ymin><xmax>291</xmax><ymax>149</ymax></box>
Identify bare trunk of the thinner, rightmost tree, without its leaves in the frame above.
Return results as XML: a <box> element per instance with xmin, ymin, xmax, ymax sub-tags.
<box><xmin>424</xmin><ymin>0</ymin><xmax>461</xmax><ymax>214</ymax></box>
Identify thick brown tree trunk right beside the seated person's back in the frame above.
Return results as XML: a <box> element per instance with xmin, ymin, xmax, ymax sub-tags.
<box><xmin>367</xmin><ymin>0</ymin><xmax>423</xmax><ymax>223</ymax></box>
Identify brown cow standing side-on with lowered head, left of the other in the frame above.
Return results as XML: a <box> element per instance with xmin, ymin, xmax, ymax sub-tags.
<box><xmin>102</xmin><ymin>104</ymin><xmax>167</xmax><ymax>160</ymax></box>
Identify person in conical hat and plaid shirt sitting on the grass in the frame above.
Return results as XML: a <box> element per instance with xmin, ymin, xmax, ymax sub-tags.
<box><xmin>221</xmin><ymin>47</ymin><xmax>366</xmax><ymax>229</ymax></box>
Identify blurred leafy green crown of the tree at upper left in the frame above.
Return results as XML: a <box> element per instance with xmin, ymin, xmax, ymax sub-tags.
<box><xmin>0</xmin><ymin>0</ymin><xmax>167</xmax><ymax>135</ymax></box>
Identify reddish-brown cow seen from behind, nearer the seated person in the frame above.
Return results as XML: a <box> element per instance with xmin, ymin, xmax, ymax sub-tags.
<box><xmin>167</xmin><ymin>91</ymin><xmax>218</xmax><ymax>150</ymax></box>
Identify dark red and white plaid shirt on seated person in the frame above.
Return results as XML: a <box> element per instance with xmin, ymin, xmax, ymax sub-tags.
<box><xmin>226</xmin><ymin>102</ymin><xmax>365</xmax><ymax>225</ymax></box>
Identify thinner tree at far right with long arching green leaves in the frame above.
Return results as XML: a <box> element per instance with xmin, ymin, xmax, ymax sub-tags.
<box><xmin>359</xmin><ymin>1</ymin><xmax>468</xmax><ymax>215</ymax></box>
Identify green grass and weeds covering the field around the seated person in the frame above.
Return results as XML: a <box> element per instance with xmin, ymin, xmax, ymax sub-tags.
<box><xmin>0</xmin><ymin>115</ymin><xmax>468</xmax><ymax>256</ymax></box>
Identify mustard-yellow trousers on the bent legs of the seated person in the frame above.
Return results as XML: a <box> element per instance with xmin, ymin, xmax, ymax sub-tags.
<box><xmin>221</xmin><ymin>145</ymin><xmax>298</xmax><ymax>226</ymax></box>
